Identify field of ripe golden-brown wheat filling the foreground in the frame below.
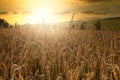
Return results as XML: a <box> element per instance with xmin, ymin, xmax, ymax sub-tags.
<box><xmin>0</xmin><ymin>28</ymin><xmax>120</xmax><ymax>80</ymax></box>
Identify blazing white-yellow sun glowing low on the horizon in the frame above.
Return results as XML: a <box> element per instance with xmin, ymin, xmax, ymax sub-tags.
<box><xmin>28</xmin><ymin>7</ymin><xmax>58</xmax><ymax>24</ymax></box>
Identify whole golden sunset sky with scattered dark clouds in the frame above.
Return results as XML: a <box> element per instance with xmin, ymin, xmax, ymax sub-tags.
<box><xmin>0</xmin><ymin>0</ymin><xmax>120</xmax><ymax>24</ymax></box>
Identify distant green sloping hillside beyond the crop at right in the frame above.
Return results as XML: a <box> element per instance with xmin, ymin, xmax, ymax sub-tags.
<box><xmin>70</xmin><ymin>18</ymin><xmax>120</xmax><ymax>31</ymax></box>
